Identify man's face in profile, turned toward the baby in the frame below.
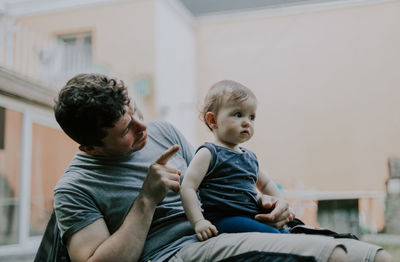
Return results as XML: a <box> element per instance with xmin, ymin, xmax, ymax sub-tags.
<box><xmin>96</xmin><ymin>102</ymin><xmax>147</xmax><ymax>156</ymax></box>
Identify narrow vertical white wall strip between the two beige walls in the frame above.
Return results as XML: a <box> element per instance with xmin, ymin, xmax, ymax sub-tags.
<box><xmin>154</xmin><ymin>0</ymin><xmax>197</xmax><ymax>143</ymax></box>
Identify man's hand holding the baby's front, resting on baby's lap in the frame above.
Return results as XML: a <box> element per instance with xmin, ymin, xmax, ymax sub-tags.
<box><xmin>255</xmin><ymin>195</ymin><xmax>295</xmax><ymax>229</ymax></box>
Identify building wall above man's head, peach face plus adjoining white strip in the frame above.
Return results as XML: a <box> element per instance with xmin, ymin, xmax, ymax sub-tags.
<box><xmin>17</xmin><ymin>0</ymin><xmax>196</xmax><ymax>140</ymax></box>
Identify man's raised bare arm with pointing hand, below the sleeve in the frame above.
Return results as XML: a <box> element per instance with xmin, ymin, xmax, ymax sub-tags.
<box><xmin>67</xmin><ymin>145</ymin><xmax>180</xmax><ymax>262</ymax></box>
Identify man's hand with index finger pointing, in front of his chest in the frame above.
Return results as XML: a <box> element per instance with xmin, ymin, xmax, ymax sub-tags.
<box><xmin>141</xmin><ymin>145</ymin><xmax>181</xmax><ymax>205</ymax></box>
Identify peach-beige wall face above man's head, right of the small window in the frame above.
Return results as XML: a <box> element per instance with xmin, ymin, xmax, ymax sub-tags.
<box><xmin>16</xmin><ymin>0</ymin><xmax>156</xmax><ymax>119</ymax></box>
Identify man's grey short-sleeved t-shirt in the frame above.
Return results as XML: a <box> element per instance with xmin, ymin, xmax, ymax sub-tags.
<box><xmin>54</xmin><ymin>121</ymin><xmax>197</xmax><ymax>261</ymax></box>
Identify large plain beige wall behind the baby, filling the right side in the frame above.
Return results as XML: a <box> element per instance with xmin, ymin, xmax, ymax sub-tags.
<box><xmin>197</xmin><ymin>1</ymin><xmax>400</xmax><ymax>190</ymax></box>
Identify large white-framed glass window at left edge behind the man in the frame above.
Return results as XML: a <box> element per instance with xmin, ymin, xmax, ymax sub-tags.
<box><xmin>0</xmin><ymin>99</ymin><xmax>78</xmax><ymax>260</ymax></box>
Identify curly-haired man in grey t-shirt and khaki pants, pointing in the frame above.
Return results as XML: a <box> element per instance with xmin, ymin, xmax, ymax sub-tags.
<box><xmin>54</xmin><ymin>74</ymin><xmax>390</xmax><ymax>261</ymax></box>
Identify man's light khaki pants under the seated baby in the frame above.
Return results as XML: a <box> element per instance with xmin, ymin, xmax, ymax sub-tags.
<box><xmin>169</xmin><ymin>233</ymin><xmax>381</xmax><ymax>262</ymax></box>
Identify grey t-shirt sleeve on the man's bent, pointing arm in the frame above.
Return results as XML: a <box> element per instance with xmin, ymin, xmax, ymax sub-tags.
<box><xmin>54</xmin><ymin>177</ymin><xmax>103</xmax><ymax>244</ymax></box>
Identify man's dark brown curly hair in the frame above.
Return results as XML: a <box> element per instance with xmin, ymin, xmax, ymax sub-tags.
<box><xmin>54</xmin><ymin>74</ymin><xmax>130</xmax><ymax>146</ymax></box>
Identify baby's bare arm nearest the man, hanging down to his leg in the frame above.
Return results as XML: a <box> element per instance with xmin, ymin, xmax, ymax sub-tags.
<box><xmin>180</xmin><ymin>148</ymin><xmax>218</xmax><ymax>241</ymax></box>
